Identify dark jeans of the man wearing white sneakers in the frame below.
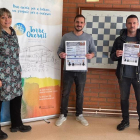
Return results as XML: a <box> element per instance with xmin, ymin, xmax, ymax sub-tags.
<box><xmin>61</xmin><ymin>71</ymin><xmax>86</xmax><ymax>117</ymax></box>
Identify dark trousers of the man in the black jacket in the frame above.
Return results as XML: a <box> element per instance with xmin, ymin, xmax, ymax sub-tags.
<box><xmin>119</xmin><ymin>77</ymin><xmax>140</xmax><ymax>121</ymax></box>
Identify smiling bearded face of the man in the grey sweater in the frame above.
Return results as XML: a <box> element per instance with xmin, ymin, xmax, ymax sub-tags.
<box><xmin>74</xmin><ymin>17</ymin><xmax>85</xmax><ymax>32</ymax></box>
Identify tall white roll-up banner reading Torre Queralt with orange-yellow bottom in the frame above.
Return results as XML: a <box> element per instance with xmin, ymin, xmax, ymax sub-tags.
<box><xmin>0</xmin><ymin>0</ymin><xmax>63</xmax><ymax>121</ymax></box>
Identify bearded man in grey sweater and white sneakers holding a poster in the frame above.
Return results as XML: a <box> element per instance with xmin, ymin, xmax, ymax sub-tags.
<box><xmin>55</xmin><ymin>15</ymin><xmax>96</xmax><ymax>126</ymax></box>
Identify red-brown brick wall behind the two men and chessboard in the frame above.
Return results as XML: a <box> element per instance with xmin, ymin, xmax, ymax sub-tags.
<box><xmin>63</xmin><ymin>0</ymin><xmax>140</xmax><ymax>110</ymax></box>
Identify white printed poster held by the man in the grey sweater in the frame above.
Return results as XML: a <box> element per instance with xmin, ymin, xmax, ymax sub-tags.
<box><xmin>65</xmin><ymin>40</ymin><xmax>87</xmax><ymax>70</ymax></box>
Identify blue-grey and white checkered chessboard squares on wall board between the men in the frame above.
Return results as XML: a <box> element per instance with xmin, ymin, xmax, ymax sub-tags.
<box><xmin>84</xmin><ymin>15</ymin><xmax>126</xmax><ymax>64</ymax></box>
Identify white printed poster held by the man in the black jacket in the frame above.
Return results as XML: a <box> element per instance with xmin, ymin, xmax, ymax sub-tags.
<box><xmin>122</xmin><ymin>43</ymin><xmax>140</xmax><ymax>66</ymax></box>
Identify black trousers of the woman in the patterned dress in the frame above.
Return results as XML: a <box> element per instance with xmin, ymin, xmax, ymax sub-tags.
<box><xmin>0</xmin><ymin>96</ymin><xmax>23</xmax><ymax>127</ymax></box>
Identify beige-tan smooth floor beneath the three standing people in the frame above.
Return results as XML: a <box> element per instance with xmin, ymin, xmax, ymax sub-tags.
<box><xmin>2</xmin><ymin>116</ymin><xmax>140</xmax><ymax>140</ymax></box>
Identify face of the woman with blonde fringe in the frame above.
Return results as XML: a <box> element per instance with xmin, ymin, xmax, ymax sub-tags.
<box><xmin>0</xmin><ymin>12</ymin><xmax>12</xmax><ymax>29</ymax></box>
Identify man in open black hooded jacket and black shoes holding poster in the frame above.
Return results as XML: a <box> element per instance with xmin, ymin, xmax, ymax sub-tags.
<box><xmin>110</xmin><ymin>15</ymin><xmax>140</xmax><ymax>131</ymax></box>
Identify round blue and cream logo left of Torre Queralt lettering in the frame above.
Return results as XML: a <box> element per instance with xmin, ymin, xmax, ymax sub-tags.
<box><xmin>13</xmin><ymin>23</ymin><xmax>26</xmax><ymax>35</ymax></box>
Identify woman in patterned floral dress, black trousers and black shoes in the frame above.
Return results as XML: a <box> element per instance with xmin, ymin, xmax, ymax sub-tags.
<box><xmin>0</xmin><ymin>8</ymin><xmax>31</xmax><ymax>139</ymax></box>
